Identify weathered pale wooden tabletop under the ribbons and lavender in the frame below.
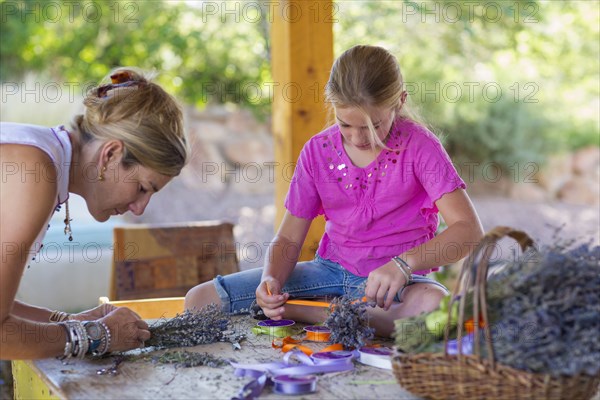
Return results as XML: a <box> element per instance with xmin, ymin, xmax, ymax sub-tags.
<box><xmin>31</xmin><ymin>317</ymin><xmax>415</xmax><ymax>399</ymax></box>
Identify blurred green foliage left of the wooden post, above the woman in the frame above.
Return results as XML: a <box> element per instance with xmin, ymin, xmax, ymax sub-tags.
<box><xmin>0</xmin><ymin>1</ymin><xmax>270</xmax><ymax>114</ymax></box>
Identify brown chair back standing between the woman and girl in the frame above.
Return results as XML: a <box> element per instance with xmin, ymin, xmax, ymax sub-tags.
<box><xmin>109</xmin><ymin>221</ymin><xmax>239</xmax><ymax>301</ymax></box>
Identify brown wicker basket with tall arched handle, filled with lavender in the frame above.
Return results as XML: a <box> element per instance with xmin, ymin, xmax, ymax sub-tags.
<box><xmin>392</xmin><ymin>227</ymin><xmax>600</xmax><ymax>400</ymax></box>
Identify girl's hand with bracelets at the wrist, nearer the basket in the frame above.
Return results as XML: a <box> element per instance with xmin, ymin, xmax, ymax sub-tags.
<box><xmin>365</xmin><ymin>260</ymin><xmax>407</xmax><ymax>311</ymax></box>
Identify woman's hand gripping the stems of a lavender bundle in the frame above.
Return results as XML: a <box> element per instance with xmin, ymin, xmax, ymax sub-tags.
<box><xmin>100</xmin><ymin>307</ymin><xmax>150</xmax><ymax>351</ymax></box>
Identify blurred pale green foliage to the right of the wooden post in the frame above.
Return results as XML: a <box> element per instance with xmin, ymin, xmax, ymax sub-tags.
<box><xmin>335</xmin><ymin>0</ymin><xmax>600</xmax><ymax>169</ymax></box>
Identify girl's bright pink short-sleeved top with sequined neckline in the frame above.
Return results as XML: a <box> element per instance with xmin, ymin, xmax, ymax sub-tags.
<box><xmin>284</xmin><ymin>120</ymin><xmax>466</xmax><ymax>277</ymax></box>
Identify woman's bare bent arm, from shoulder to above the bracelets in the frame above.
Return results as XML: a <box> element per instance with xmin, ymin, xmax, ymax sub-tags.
<box><xmin>0</xmin><ymin>144</ymin><xmax>66</xmax><ymax>359</ymax></box>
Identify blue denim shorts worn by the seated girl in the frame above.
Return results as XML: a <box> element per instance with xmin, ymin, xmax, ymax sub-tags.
<box><xmin>213</xmin><ymin>255</ymin><xmax>448</xmax><ymax>314</ymax></box>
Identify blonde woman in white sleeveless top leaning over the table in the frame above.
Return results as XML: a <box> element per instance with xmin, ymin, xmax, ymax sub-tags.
<box><xmin>0</xmin><ymin>68</ymin><xmax>188</xmax><ymax>359</ymax></box>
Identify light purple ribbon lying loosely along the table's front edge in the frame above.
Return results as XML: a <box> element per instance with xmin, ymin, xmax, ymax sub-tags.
<box><xmin>231</xmin><ymin>350</ymin><xmax>354</xmax><ymax>400</ymax></box>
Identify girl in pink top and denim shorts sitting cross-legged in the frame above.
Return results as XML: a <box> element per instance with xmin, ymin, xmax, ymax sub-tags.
<box><xmin>186</xmin><ymin>46</ymin><xmax>483</xmax><ymax>336</ymax></box>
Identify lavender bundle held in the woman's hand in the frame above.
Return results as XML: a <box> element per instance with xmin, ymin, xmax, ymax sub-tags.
<box><xmin>146</xmin><ymin>304</ymin><xmax>230</xmax><ymax>348</ymax></box>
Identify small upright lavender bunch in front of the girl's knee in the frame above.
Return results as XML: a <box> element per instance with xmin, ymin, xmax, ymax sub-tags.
<box><xmin>325</xmin><ymin>296</ymin><xmax>375</xmax><ymax>349</ymax></box>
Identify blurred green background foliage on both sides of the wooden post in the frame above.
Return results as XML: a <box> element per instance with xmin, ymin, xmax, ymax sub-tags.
<box><xmin>0</xmin><ymin>0</ymin><xmax>600</xmax><ymax>173</ymax></box>
